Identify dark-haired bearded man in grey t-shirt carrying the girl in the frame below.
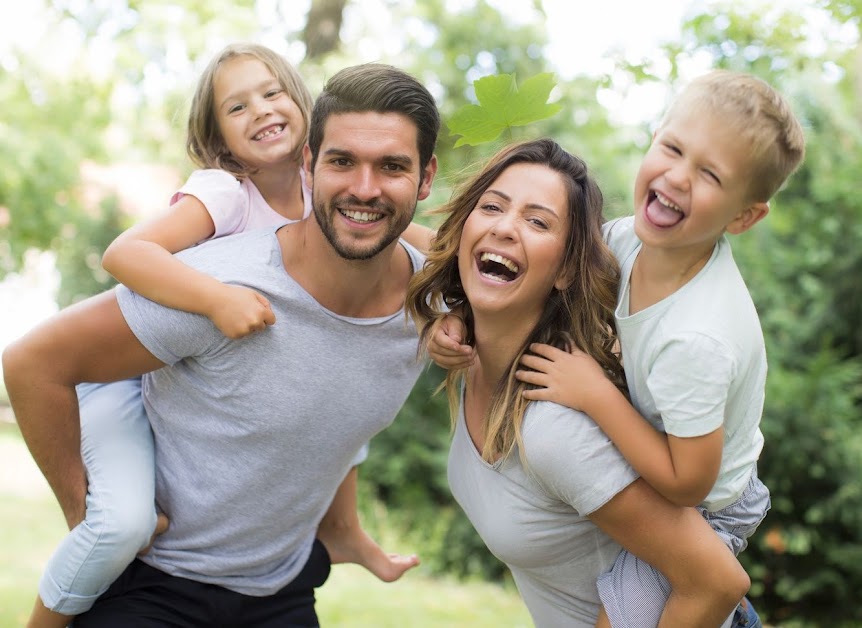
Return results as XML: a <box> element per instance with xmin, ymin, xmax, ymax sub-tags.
<box><xmin>3</xmin><ymin>64</ymin><xmax>439</xmax><ymax>626</ymax></box>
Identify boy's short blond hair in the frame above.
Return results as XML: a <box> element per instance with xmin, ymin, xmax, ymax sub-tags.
<box><xmin>662</xmin><ymin>70</ymin><xmax>805</xmax><ymax>202</ymax></box>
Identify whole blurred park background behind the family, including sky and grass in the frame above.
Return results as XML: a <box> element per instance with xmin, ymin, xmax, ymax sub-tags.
<box><xmin>0</xmin><ymin>0</ymin><xmax>862</xmax><ymax>626</ymax></box>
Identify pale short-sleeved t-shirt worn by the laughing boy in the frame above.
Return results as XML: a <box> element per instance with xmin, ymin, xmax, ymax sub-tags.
<box><xmin>604</xmin><ymin>217</ymin><xmax>766</xmax><ymax>511</ymax></box>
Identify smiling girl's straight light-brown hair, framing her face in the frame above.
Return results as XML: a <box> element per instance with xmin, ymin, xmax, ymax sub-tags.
<box><xmin>186</xmin><ymin>43</ymin><xmax>313</xmax><ymax>177</ymax></box>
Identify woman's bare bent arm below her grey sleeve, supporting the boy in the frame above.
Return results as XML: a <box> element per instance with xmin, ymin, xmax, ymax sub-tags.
<box><xmin>588</xmin><ymin>479</ymin><xmax>751</xmax><ymax>627</ymax></box>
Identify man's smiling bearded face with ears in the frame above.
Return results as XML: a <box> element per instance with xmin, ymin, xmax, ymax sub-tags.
<box><xmin>305</xmin><ymin>112</ymin><xmax>437</xmax><ymax>260</ymax></box>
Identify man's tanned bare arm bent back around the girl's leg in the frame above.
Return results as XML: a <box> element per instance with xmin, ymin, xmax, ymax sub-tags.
<box><xmin>3</xmin><ymin>290</ymin><xmax>164</xmax><ymax>528</ymax></box>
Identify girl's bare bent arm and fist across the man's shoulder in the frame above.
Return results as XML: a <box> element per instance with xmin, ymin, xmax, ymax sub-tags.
<box><xmin>102</xmin><ymin>195</ymin><xmax>275</xmax><ymax>338</ymax></box>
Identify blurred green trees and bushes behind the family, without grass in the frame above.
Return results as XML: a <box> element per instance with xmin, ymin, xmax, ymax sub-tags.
<box><xmin>0</xmin><ymin>0</ymin><xmax>862</xmax><ymax>626</ymax></box>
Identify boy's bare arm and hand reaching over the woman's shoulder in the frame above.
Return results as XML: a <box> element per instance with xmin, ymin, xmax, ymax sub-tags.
<box><xmin>517</xmin><ymin>344</ymin><xmax>724</xmax><ymax>506</ymax></box>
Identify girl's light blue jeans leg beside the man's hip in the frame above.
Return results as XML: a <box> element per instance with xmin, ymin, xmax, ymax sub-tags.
<box><xmin>39</xmin><ymin>378</ymin><xmax>156</xmax><ymax>615</ymax></box>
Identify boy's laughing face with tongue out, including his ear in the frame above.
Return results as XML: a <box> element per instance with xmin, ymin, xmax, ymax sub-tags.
<box><xmin>635</xmin><ymin>108</ymin><xmax>768</xmax><ymax>257</ymax></box>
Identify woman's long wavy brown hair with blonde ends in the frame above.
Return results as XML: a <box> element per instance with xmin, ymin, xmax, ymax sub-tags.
<box><xmin>406</xmin><ymin>139</ymin><xmax>626</xmax><ymax>462</ymax></box>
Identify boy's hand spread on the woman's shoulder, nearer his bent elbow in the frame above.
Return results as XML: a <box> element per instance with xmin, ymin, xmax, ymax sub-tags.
<box><xmin>515</xmin><ymin>343</ymin><xmax>613</xmax><ymax>414</ymax></box>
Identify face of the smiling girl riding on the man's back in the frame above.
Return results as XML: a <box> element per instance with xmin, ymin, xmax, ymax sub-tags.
<box><xmin>213</xmin><ymin>56</ymin><xmax>306</xmax><ymax>170</ymax></box>
